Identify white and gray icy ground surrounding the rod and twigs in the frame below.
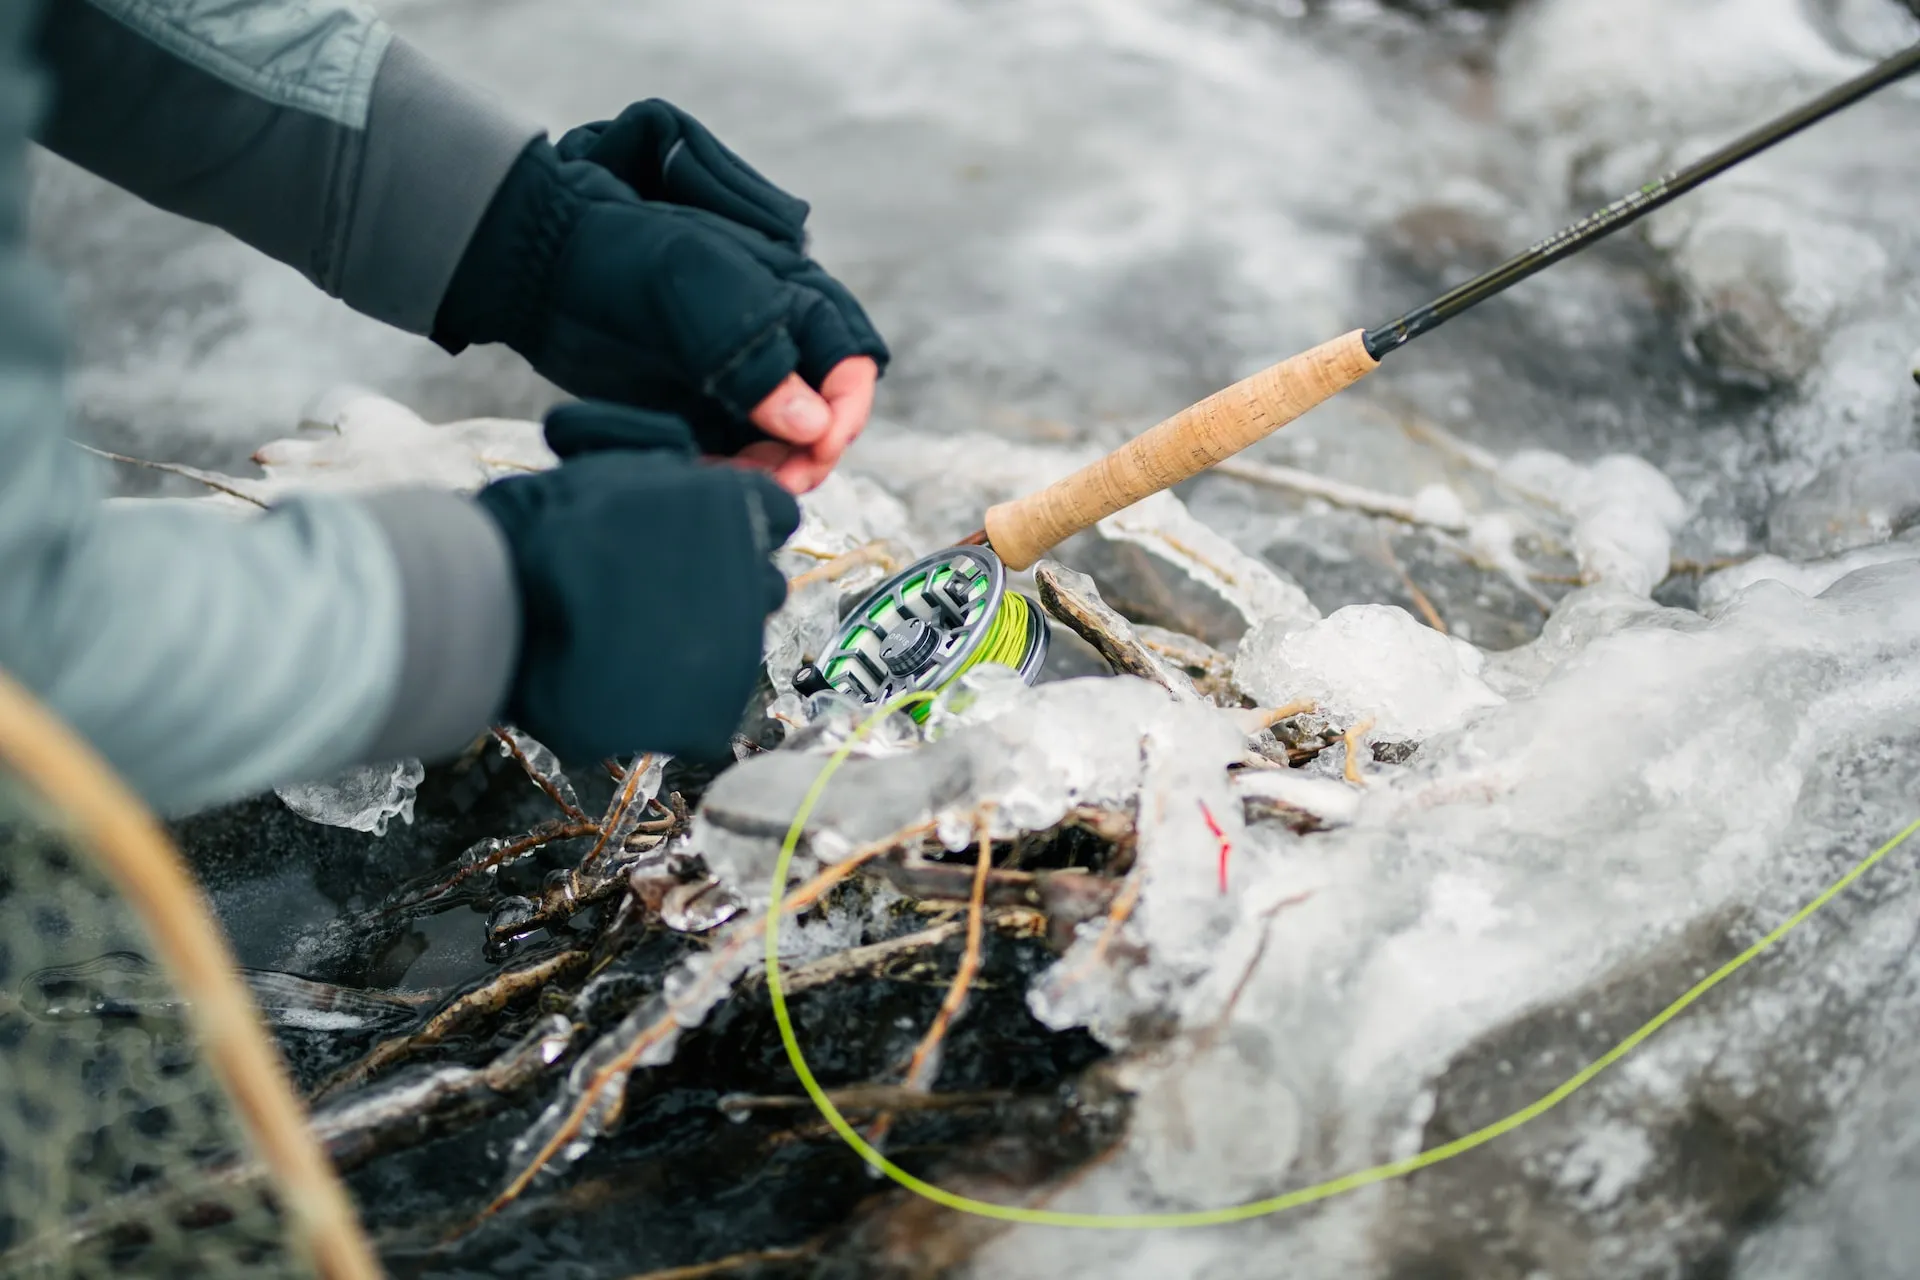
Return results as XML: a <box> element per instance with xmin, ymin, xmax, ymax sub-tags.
<box><xmin>38</xmin><ymin>0</ymin><xmax>1920</xmax><ymax>1280</ymax></box>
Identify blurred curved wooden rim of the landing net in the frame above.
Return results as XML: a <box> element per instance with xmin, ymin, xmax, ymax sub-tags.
<box><xmin>0</xmin><ymin>674</ymin><xmax>380</xmax><ymax>1280</ymax></box>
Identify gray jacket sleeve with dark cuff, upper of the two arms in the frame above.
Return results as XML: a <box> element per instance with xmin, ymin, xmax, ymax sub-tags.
<box><xmin>38</xmin><ymin>0</ymin><xmax>540</xmax><ymax>334</ymax></box>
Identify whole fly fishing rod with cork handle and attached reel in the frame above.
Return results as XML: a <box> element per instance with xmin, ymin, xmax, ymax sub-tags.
<box><xmin>795</xmin><ymin>44</ymin><xmax>1920</xmax><ymax>704</ymax></box>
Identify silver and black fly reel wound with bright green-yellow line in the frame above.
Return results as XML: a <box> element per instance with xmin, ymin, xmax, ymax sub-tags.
<box><xmin>793</xmin><ymin>547</ymin><xmax>1046</xmax><ymax>720</ymax></box>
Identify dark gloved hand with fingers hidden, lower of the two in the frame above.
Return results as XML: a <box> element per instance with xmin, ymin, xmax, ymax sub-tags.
<box><xmin>478</xmin><ymin>405</ymin><xmax>801</xmax><ymax>762</ymax></box>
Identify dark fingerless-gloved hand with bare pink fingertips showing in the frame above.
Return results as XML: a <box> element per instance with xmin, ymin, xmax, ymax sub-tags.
<box><xmin>434</xmin><ymin>102</ymin><xmax>887</xmax><ymax>491</ymax></box>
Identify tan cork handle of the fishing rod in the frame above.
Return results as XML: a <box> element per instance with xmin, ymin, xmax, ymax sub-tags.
<box><xmin>987</xmin><ymin>328</ymin><xmax>1380</xmax><ymax>570</ymax></box>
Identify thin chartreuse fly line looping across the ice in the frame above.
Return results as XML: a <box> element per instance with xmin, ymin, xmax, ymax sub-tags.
<box><xmin>766</xmin><ymin>693</ymin><xmax>1920</xmax><ymax>1230</ymax></box>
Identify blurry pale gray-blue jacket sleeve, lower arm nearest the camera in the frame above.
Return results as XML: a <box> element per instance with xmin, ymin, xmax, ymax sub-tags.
<box><xmin>0</xmin><ymin>0</ymin><xmax>518</xmax><ymax>812</ymax></box>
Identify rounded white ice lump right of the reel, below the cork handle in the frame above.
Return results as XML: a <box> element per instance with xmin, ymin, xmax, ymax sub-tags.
<box><xmin>1233</xmin><ymin>604</ymin><xmax>1501</xmax><ymax>741</ymax></box>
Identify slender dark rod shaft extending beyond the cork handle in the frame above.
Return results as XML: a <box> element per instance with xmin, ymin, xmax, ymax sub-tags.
<box><xmin>1363</xmin><ymin>44</ymin><xmax>1920</xmax><ymax>359</ymax></box>
